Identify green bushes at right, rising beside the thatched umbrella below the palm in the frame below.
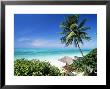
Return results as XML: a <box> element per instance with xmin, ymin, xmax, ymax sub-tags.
<box><xmin>70</xmin><ymin>48</ymin><xmax>97</xmax><ymax>75</ymax></box>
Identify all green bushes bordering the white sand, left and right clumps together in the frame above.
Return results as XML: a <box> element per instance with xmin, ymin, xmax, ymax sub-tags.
<box><xmin>14</xmin><ymin>48</ymin><xmax>97</xmax><ymax>76</ymax></box>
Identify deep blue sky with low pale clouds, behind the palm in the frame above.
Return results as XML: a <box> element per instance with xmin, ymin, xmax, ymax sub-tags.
<box><xmin>14</xmin><ymin>14</ymin><xmax>97</xmax><ymax>48</ymax></box>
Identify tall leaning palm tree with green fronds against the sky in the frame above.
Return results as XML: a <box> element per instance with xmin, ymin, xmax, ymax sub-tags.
<box><xmin>60</xmin><ymin>15</ymin><xmax>90</xmax><ymax>57</ymax></box>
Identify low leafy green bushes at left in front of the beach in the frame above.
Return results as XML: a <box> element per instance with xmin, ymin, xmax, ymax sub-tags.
<box><xmin>14</xmin><ymin>59</ymin><xmax>61</xmax><ymax>76</ymax></box>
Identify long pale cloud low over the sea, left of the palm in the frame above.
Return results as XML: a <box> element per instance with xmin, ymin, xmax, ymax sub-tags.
<box><xmin>16</xmin><ymin>37</ymin><xmax>64</xmax><ymax>48</ymax></box>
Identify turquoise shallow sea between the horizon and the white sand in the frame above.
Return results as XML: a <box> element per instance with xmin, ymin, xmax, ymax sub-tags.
<box><xmin>14</xmin><ymin>48</ymin><xmax>90</xmax><ymax>61</ymax></box>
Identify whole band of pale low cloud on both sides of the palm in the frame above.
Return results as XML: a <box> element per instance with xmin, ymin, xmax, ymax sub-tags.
<box><xmin>17</xmin><ymin>37</ymin><xmax>96</xmax><ymax>48</ymax></box>
